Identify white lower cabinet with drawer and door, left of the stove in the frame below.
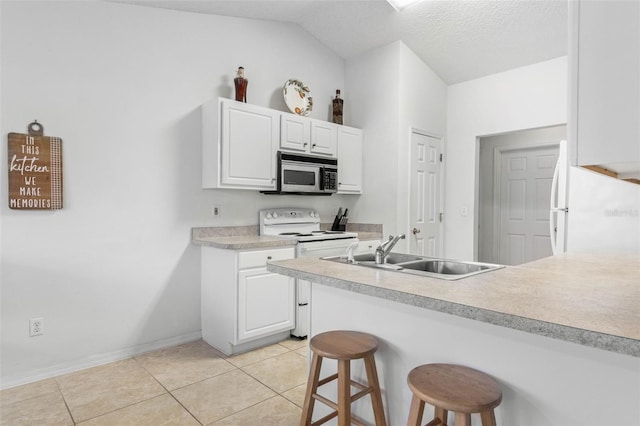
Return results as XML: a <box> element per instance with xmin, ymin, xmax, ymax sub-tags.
<box><xmin>201</xmin><ymin>247</ymin><xmax>296</xmax><ymax>355</ymax></box>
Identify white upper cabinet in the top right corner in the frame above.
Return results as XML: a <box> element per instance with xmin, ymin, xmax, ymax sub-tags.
<box><xmin>569</xmin><ymin>1</ymin><xmax>640</xmax><ymax>170</ymax></box>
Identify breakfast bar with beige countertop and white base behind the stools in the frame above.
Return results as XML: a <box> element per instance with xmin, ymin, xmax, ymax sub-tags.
<box><xmin>267</xmin><ymin>254</ymin><xmax>640</xmax><ymax>426</ymax></box>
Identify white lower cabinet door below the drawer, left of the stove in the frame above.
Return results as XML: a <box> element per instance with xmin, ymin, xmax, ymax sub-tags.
<box><xmin>238</xmin><ymin>268</ymin><xmax>295</xmax><ymax>341</ymax></box>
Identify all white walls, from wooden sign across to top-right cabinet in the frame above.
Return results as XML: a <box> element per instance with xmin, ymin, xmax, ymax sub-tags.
<box><xmin>0</xmin><ymin>1</ymin><xmax>566</xmax><ymax>387</ymax></box>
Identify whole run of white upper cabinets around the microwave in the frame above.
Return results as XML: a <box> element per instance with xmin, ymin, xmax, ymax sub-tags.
<box><xmin>202</xmin><ymin>98</ymin><xmax>362</xmax><ymax>194</ymax></box>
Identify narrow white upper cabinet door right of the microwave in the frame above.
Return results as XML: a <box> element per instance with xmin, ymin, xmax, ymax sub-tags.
<box><xmin>338</xmin><ymin>126</ymin><xmax>363</xmax><ymax>194</ymax></box>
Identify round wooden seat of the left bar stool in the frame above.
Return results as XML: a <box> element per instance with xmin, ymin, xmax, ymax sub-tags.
<box><xmin>309</xmin><ymin>330</ymin><xmax>378</xmax><ymax>359</ymax></box>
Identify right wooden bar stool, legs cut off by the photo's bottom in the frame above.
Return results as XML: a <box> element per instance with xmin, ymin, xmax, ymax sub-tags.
<box><xmin>407</xmin><ymin>364</ymin><xmax>502</xmax><ymax>426</ymax></box>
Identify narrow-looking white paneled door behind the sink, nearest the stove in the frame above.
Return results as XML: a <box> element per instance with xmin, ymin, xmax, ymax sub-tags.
<box><xmin>407</xmin><ymin>132</ymin><xmax>442</xmax><ymax>256</ymax></box>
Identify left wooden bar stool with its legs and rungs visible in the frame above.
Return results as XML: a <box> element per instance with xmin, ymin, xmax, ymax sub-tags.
<box><xmin>300</xmin><ymin>330</ymin><xmax>386</xmax><ymax>426</ymax></box>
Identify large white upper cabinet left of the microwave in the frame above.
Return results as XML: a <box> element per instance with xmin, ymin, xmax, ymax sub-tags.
<box><xmin>202</xmin><ymin>98</ymin><xmax>280</xmax><ymax>190</ymax></box>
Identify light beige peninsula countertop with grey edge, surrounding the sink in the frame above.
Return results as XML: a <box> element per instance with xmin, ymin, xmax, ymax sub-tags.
<box><xmin>267</xmin><ymin>254</ymin><xmax>640</xmax><ymax>357</ymax></box>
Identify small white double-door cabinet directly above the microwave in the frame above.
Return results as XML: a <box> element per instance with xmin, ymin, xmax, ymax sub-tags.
<box><xmin>280</xmin><ymin>113</ymin><xmax>339</xmax><ymax>157</ymax></box>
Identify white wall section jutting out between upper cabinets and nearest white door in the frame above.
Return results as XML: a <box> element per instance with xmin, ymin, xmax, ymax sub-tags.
<box><xmin>345</xmin><ymin>41</ymin><xmax>447</xmax><ymax>245</ymax></box>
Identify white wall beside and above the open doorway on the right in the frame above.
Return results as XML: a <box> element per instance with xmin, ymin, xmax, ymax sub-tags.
<box><xmin>445</xmin><ymin>57</ymin><xmax>567</xmax><ymax>260</ymax></box>
